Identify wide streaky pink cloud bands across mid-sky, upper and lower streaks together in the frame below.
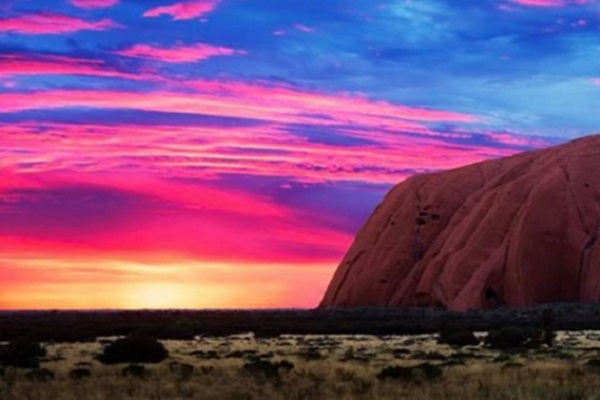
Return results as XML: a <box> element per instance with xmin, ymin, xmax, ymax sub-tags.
<box><xmin>0</xmin><ymin>81</ymin><xmax>544</xmax><ymax>189</ymax></box>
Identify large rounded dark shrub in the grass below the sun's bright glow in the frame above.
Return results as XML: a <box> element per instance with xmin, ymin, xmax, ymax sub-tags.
<box><xmin>98</xmin><ymin>336</ymin><xmax>169</xmax><ymax>364</ymax></box>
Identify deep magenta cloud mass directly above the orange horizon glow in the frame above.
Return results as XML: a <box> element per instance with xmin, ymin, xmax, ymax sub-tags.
<box><xmin>0</xmin><ymin>166</ymin><xmax>351</xmax><ymax>264</ymax></box>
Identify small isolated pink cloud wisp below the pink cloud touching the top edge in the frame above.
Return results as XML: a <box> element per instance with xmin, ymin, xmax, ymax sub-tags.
<box><xmin>115</xmin><ymin>43</ymin><xmax>241</xmax><ymax>63</ymax></box>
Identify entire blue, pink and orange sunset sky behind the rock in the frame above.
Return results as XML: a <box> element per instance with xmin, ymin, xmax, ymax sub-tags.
<box><xmin>0</xmin><ymin>0</ymin><xmax>600</xmax><ymax>309</ymax></box>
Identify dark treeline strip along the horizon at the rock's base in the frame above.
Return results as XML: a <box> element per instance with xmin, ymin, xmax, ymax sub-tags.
<box><xmin>0</xmin><ymin>304</ymin><xmax>600</xmax><ymax>342</ymax></box>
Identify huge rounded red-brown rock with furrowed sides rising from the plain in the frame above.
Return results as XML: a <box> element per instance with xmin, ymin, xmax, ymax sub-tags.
<box><xmin>321</xmin><ymin>135</ymin><xmax>600</xmax><ymax>311</ymax></box>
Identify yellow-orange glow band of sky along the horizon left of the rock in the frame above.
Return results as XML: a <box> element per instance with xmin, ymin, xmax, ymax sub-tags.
<box><xmin>0</xmin><ymin>255</ymin><xmax>333</xmax><ymax>309</ymax></box>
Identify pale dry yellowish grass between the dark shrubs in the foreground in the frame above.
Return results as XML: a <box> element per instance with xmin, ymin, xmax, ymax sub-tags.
<box><xmin>0</xmin><ymin>332</ymin><xmax>600</xmax><ymax>400</ymax></box>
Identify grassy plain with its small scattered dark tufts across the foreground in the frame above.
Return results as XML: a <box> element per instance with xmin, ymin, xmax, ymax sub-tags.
<box><xmin>0</xmin><ymin>327</ymin><xmax>600</xmax><ymax>400</ymax></box>
